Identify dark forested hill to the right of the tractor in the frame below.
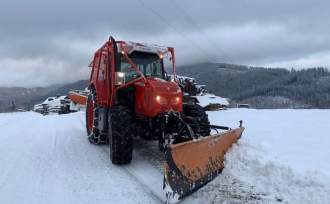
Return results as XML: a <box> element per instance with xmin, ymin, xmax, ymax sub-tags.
<box><xmin>178</xmin><ymin>63</ymin><xmax>330</xmax><ymax>108</ymax></box>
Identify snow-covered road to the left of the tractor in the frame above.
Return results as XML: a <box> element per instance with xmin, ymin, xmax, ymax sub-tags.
<box><xmin>0</xmin><ymin>112</ymin><xmax>159</xmax><ymax>204</ymax></box>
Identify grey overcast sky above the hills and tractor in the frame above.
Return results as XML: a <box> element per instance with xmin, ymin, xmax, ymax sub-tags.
<box><xmin>0</xmin><ymin>0</ymin><xmax>330</xmax><ymax>87</ymax></box>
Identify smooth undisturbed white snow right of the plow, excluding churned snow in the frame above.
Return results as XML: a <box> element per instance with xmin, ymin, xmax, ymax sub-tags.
<box><xmin>208</xmin><ymin>109</ymin><xmax>330</xmax><ymax>178</ymax></box>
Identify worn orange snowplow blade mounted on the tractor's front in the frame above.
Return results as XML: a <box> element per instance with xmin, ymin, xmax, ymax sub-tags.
<box><xmin>164</xmin><ymin>127</ymin><xmax>244</xmax><ymax>201</ymax></box>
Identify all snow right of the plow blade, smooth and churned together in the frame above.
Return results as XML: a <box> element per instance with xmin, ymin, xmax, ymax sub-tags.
<box><xmin>193</xmin><ymin>109</ymin><xmax>330</xmax><ymax>204</ymax></box>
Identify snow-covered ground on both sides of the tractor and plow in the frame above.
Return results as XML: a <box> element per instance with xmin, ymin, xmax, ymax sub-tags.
<box><xmin>0</xmin><ymin>109</ymin><xmax>330</xmax><ymax>204</ymax></box>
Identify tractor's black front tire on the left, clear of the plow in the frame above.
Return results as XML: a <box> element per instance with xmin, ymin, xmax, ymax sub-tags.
<box><xmin>108</xmin><ymin>106</ymin><xmax>134</xmax><ymax>164</ymax></box>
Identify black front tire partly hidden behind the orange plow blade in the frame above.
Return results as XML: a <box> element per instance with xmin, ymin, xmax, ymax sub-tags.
<box><xmin>183</xmin><ymin>104</ymin><xmax>211</xmax><ymax>136</ymax></box>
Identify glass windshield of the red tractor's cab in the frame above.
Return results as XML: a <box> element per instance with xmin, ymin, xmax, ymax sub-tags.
<box><xmin>120</xmin><ymin>51</ymin><xmax>164</xmax><ymax>81</ymax></box>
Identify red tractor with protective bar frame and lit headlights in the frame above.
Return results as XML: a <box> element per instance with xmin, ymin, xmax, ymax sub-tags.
<box><xmin>86</xmin><ymin>37</ymin><xmax>245</xmax><ymax>199</ymax></box>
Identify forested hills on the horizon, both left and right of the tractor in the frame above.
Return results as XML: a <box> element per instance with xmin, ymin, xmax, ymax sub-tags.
<box><xmin>0</xmin><ymin>63</ymin><xmax>330</xmax><ymax>112</ymax></box>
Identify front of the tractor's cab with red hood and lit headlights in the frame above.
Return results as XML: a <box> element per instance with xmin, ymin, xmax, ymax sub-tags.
<box><xmin>116</xmin><ymin>42</ymin><xmax>182</xmax><ymax>117</ymax></box>
